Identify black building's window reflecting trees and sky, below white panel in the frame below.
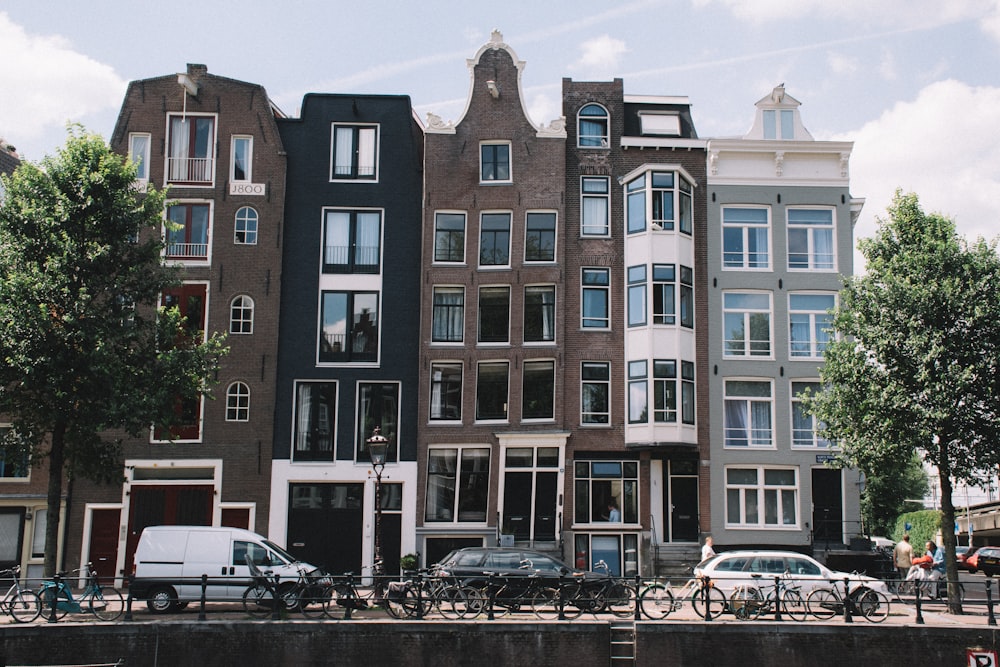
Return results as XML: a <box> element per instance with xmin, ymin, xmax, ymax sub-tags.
<box><xmin>319</xmin><ymin>292</ymin><xmax>379</xmax><ymax>361</ymax></box>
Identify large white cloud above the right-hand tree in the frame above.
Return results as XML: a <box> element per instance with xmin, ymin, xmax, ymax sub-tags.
<box><xmin>839</xmin><ymin>80</ymin><xmax>1000</xmax><ymax>269</ymax></box>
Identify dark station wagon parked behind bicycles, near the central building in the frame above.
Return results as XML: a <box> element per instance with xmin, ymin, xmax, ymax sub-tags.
<box><xmin>438</xmin><ymin>547</ymin><xmax>601</xmax><ymax>589</ymax></box>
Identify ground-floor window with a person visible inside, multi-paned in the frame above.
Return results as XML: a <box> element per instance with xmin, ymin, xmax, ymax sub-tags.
<box><xmin>573</xmin><ymin>461</ymin><xmax>639</xmax><ymax>523</ymax></box>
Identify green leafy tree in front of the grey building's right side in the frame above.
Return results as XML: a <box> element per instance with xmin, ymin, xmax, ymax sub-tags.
<box><xmin>808</xmin><ymin>191</ymin><xmax>1000</xmax><ymax>613</ymax></box>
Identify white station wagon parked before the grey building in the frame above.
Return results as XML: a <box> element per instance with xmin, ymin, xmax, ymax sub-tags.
<box><xmin>694</xmin><ymin>551</ymin><xmax>887</xmax><ymax>596</ymax></box>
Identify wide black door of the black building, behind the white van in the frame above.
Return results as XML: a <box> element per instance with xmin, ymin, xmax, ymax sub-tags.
<box><xmin>286</xmin><ymin>484</ymin><xmax>367</xmax><ymax>575</ymax></box>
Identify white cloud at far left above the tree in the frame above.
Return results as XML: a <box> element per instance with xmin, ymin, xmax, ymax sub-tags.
<box><xmin>0</xmin><ymin>12</ymin><xmax>126</xmax><ymax>160</ymax></box>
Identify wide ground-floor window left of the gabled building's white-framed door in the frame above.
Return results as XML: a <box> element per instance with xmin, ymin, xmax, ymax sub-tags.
<box><xmin>424</xmin><ymin>447</ymin><xmax>490</xmax><ymax>523</ymax></box>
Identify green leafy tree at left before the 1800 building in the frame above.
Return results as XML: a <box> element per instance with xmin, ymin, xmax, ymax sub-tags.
<box><xmin>0</xmin><ymin>127</ymin><xmax>226</xmax><ymax>575</ymax></box>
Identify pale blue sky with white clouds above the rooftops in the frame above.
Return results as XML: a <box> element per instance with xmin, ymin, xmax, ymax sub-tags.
<box><xmin>0</xmin><ymin>0</ymin><xmax>1000</xmax><ymax>267</ymax></box>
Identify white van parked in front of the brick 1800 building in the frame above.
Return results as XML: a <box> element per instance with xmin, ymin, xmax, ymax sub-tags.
<box><xmin>129</xmin><ymin>526</ymin><xmax>316</xmax><ymax>614</ymax></box>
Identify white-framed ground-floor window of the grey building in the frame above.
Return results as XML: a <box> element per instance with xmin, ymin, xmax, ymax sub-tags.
<box><xmin>723</xmin><ymin>465</ymin><xmax>802</xmax><ymax>530</ymax></box>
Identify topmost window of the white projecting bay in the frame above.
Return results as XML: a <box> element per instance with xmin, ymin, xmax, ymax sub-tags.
<box><xmin>625</xmin><ymin>171</ymin><xmax>694</xmax><ymax>235</ymax></box>
